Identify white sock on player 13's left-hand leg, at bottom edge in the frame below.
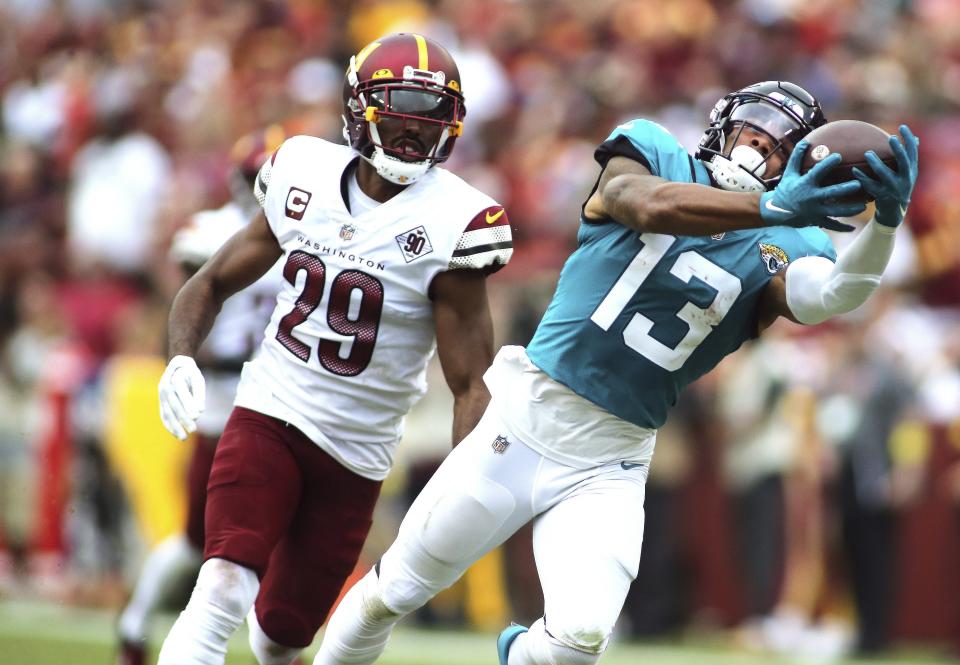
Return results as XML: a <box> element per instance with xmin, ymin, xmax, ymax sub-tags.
<box><xmin>313</xmin><ymin>569</ymin><xmax>402</xmax><ymax>665</ymax></box>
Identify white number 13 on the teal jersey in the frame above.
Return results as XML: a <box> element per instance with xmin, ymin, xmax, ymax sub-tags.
<box><xmin>590</xmin><ymin>233</ymin><xmax>743</xmax><ymax>372</ymax></box>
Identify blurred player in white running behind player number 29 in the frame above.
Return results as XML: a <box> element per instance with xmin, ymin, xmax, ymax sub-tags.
<box><xmin>117</xmin><ymin>125</ymin><xmax>283</xmax><ymax>665</ymax></box>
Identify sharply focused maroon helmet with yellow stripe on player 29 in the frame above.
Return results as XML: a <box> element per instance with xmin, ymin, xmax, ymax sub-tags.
<box><xmin>343</xmin><ymin>33</ymin><xmax>466</xmax><ymax>185</ymax></box>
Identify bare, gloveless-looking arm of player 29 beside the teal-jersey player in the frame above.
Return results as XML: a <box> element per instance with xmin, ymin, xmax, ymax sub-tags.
<box><xmin>430</xmin><ymin>270</ymin><xmax>493</xmax><ymax>445</ymax></box>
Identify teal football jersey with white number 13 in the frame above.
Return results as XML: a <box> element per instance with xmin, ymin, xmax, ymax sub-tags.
<box><xmin>527</xmin><ymin>120</ymin><xmax>836</xmax><ymax>428</ymax></box>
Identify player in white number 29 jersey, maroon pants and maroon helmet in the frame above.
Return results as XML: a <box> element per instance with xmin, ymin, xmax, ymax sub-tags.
<box><xmin>152</xmin><ymin>34</ymin><xmax>512</xmax><ymax>665</ymax></box>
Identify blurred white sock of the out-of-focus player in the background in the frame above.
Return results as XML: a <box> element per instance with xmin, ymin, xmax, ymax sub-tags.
<box><xmin>117</xmin><ymin>533</ymin><xmax>203</xmax><ymax>642</ymax></box>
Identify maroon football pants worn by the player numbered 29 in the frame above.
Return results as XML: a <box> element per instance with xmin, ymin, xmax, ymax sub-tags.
<box><xmin>204</xmin><ymin>407</ymin><xmax>380</xmax><ymax>647</ymax></box>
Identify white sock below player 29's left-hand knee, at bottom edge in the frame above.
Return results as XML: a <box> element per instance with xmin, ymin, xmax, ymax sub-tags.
<box><xmin>157</xmin><ymin>559</ymin><xmax>260</xmax><ymax>665</ymax></box>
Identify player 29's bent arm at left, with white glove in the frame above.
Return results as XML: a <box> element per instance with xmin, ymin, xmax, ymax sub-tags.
<box><xmin>158</xmin><ymin>213</ymin><xmax>281</xmax><ymax>440</ymax></box>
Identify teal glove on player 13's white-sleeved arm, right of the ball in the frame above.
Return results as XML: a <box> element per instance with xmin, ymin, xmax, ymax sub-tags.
<box><xmin>853</xmin><ymin>125</ymin><xmax>920</xmax><ymax>228</ymax></box>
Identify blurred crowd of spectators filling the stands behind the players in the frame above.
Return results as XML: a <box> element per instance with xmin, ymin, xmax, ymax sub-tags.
<box><xmin>0</xmin><ymin>0</ymin><xmax>960</xmax><ymax>656</ymax></box>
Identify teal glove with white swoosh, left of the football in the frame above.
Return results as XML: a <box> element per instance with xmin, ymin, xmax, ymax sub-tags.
<box><xmin>760</xmin><ymin>141</ymin><xmax>867</xmax><ymax>231</ymax></box>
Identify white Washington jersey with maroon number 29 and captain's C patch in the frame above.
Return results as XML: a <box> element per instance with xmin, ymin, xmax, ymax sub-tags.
<box><xmin>236</xmin><ymin>136</ymin><xmax>513</xmax><ymax>480</ymax></box>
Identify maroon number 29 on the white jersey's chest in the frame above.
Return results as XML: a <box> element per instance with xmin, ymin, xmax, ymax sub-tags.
<box><xmin>277</xmin><ymin>250</ymin><xmax>383</xmax><ymax>376</ymax></box>
